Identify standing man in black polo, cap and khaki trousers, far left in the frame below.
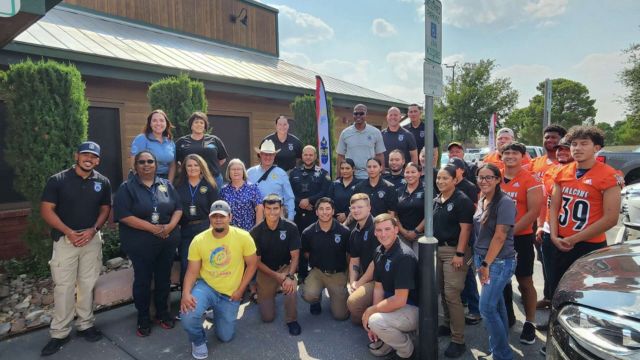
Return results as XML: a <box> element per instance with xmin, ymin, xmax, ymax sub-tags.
<box><xmin>40</xmin><ymin>141</ymin><xmax>111</xmax><ymax>356</ymax></box>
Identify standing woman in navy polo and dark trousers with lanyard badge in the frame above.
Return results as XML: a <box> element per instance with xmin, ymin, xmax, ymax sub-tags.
<box><xmin>113</xmin><ymin>150</ymin><xmax>182</xmax><ymax>337</ymax></box>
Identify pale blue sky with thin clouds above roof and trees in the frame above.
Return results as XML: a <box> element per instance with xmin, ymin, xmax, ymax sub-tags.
<box><xmin>262</xmin><ymin>0</ymin><xmax>640</xmax><ymax>123</ymax></box>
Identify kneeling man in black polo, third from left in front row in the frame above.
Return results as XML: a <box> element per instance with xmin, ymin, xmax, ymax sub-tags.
<box><xmin>302</xmin><ymin>197</ymin><xmax>349</xmax><ymax>320</ymax></box>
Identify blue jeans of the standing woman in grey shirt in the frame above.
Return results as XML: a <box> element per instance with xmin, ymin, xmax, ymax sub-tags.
<box><xmin>474</xmin><ymin>255</ymin><xmax>516</xmax><ymax>360</ymax></box>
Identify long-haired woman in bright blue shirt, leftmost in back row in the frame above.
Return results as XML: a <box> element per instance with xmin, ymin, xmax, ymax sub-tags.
<box><xmin>130</xmin><ymin>109</ymin><xmax>176</xmax><ymax>181</ymax></box>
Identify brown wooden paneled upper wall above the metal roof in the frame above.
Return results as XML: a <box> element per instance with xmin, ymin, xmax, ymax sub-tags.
<box><xmin>64</xmin><ymin>0</ymin><xmax>278</xmax><ymax>55</ymax></box>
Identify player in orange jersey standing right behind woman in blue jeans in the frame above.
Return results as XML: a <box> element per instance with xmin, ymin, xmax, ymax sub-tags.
<box><xmin>500</xmin><ymin>143</ymin><xmax>543</xmax><ymax>345</ymax></box>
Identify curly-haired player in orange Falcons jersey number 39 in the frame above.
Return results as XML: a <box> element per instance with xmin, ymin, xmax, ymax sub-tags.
<box><xmin>548</xmin><ymin>126</ymin><xmax>624</xmax><ymax>294</ymax></box>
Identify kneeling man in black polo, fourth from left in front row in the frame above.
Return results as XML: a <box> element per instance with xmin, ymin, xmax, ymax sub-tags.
<box><xmin>347</xmin><ymin>193</ymin><xmax>380</xmax><ymax>324</ymax></box>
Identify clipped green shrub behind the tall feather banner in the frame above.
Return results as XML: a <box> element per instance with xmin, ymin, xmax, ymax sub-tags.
<box><xmin>289</xmin><ymin>95</ymin><xmax>338</xmax><ymax>174</ymax></box>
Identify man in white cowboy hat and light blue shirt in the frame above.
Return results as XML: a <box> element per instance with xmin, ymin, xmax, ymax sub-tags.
<box><xmin>247</xmin><ymin>140</ymin><xmax>296</xmax><ymax>221</ymax></box>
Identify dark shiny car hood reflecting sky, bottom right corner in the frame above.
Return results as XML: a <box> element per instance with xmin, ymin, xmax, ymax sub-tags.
<box><xmin>553</xmin><ymin>240</ymin><xmax>640</xmax><ymax>320</ymax></box>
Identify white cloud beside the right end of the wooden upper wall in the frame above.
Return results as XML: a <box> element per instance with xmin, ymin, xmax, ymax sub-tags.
<box><xmin>271</xmin><ymin>5</ymin><xmax>335</xmax><ymax>46</ymax></box>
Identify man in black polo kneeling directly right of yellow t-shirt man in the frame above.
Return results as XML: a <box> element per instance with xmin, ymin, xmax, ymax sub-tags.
<box><xmin>250</xmin><ymin>194</ymin><xmax>301</xmax><ymax>336</ymax></box>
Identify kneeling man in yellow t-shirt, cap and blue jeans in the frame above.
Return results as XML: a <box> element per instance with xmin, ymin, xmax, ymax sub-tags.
<box><xmin>180</xmin><ymin>200</ymin><xmax>258</xmax><ymax>359</ymax></box>
